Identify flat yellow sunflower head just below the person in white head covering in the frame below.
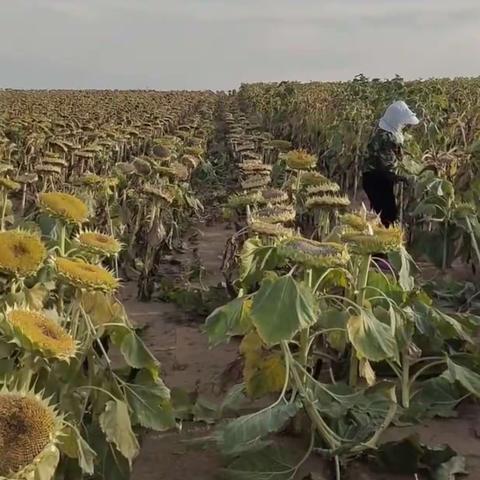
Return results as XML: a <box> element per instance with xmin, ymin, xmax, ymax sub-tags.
<box><xmin>342</xmin><ymin>226</ymin><xmax>404</xmax><ymax>255</ymax></box>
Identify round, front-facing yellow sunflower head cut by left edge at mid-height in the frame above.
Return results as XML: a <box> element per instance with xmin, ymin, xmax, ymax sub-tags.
<box><xmin>0</xmin><ymin>230</ymin><xmax>47</xmax><ymax>278</ymax></box>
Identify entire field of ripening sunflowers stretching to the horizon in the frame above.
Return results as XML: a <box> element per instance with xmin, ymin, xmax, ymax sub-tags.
<box><xmin>0</xmin><ymin>76</ymin><xmax>480</xmax><ymax>480</ymax></box>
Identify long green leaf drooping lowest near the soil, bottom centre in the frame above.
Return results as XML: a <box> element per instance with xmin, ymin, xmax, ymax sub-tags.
<box><xmin>216</xmin><ymin>403</ymin><xmax>298</xmax><ymax>455</ymax></box>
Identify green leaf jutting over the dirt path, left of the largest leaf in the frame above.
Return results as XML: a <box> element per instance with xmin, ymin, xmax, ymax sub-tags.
<box><xmin>205</xmin><ymin>297</ymin><xmax>251</xmax><ymax>346</ymax></box>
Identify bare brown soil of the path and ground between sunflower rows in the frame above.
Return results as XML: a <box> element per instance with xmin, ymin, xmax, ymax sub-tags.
<box><xmin>122</xmin><ymin>219</ymin><xmax>480</xmax><ymax>480</ymax></box>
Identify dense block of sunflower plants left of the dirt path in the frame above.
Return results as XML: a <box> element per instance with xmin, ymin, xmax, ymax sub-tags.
<box><xmin>0</xmin><ymin>92</ymin><xmax>216</xmax><ymax>480</ymax></box>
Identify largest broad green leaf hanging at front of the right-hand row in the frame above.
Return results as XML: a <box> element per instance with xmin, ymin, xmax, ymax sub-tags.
<box><xmin>252</xmin><ymin>275</ymin><xmax>317</xmax><ymax>345</ymax></box>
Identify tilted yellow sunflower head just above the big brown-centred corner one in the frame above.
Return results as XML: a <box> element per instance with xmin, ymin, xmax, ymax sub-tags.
<box><xmin>6</xmin><ymin>308</ymin><xmax>76</xmax><ymax>360</ymax></box>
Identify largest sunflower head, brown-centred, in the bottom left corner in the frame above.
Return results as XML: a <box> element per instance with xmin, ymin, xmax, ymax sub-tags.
<box><xmin>0</xmin><ymin>388</ymin><xmax>64</xmax><ymax>480</ymax></box>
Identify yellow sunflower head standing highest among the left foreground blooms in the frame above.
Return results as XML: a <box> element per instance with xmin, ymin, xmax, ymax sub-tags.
<box><xmin>39</xmin><ymin>192</ymin><xmax>88</xmax><ymax>224</ymax></box>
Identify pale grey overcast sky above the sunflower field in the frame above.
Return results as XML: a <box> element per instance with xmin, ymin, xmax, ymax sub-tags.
<box><xmin>0</xmin><ymin>0</ymin><xmax>480</xmax><ymax>89</ymax></box>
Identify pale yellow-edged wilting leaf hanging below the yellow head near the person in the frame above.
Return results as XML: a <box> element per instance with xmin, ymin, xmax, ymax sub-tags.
<box><xmin>347</xmin><ymin>311</ymin><xmax>398</xmax><ymax>362</ymax></box>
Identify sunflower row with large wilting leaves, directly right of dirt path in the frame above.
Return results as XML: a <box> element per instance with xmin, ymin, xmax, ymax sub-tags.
<box><xmin>205</xmin><ymin>106</ymin><xmax>480</xmax><ymax>479</ymax></box>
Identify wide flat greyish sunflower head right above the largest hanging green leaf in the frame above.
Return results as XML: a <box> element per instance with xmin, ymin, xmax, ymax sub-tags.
<box><xmin>278</xmin><ymin>237</ymin><xmax>350</xmax><ymax>268</ymax></box>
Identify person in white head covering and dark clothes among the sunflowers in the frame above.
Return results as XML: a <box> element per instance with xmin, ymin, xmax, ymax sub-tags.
<box><xmin>363</xmin><ymin>101</ymin><xmax>419</xmax><ymax>228</ymax></box>
